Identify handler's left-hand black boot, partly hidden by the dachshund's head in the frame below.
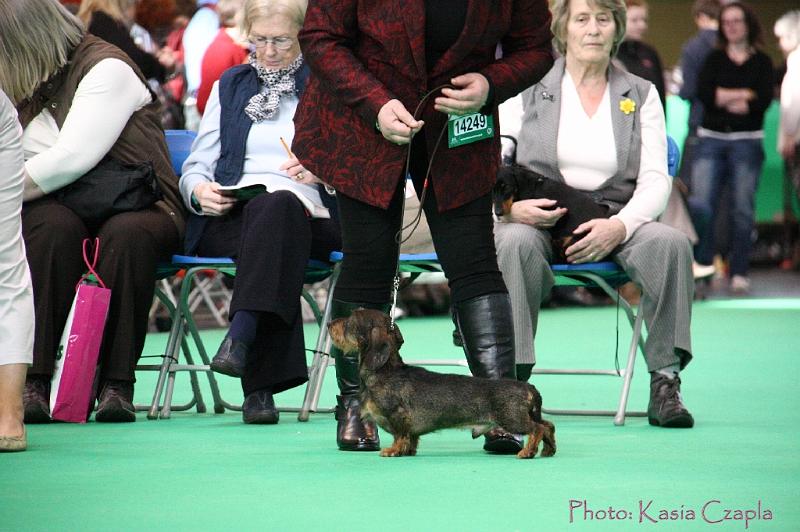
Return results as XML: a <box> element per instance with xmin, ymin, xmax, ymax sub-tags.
<box><xmin>331</xmin><ymin>299</ymin><xmax>390</xmax><ymax>451</ymax></box>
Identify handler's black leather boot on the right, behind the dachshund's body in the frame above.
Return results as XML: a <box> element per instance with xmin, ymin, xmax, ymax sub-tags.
<box><xmin>453</xmin><ymin>293</ymin><xmax>522</xmax><ymax>454</ymax></box>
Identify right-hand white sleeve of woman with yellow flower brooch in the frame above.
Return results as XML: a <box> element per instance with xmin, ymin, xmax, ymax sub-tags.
<box><xmin>612</xmin><ymin>85</ymin><xmax>672</xmax><ymax>242</ymax></box>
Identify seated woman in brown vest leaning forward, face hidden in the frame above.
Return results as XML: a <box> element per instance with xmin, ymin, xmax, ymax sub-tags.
<box><xmin>0</xmin><ymin>0</ymin><xmax>184</xmax><ymax>423</ymax></box>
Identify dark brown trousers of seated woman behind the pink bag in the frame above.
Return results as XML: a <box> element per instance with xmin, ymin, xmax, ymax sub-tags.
<box><xmin>22</xmin><ymin>197</ymin><xmax>180</xmax><ymax>382</ymax></box>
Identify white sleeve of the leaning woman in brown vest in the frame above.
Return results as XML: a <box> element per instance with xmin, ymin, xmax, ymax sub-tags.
<box><xmin>25</xmin><ymin>58</ymin><xmax>152</xmax><ymax>193</ymax></box>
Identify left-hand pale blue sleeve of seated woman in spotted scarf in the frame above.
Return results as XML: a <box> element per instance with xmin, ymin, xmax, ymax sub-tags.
<box><xmin>179</xmin><ymin>81</ymin><xmax>221</xmax><ymax>214</ymax></box>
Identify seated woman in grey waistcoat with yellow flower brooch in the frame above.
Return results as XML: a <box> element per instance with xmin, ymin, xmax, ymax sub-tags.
<box><xmin>495</xmin><ymin>0</ymin><xmax>694</xmax><ymax>427</ymax></box>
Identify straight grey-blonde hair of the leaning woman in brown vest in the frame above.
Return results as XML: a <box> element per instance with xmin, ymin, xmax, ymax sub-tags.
<box><xmin>0</xmin><ymin>0</ymin><xmax>85</xmax><ymax>104</ymax></box>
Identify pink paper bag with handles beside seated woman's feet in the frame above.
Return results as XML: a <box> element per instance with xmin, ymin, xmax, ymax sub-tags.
<box><xmin>50</xmin><ymin>239</ymin><xmax>111</xmax><ymax>423</ymax></box>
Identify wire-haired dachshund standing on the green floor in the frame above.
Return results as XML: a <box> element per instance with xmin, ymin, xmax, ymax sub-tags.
<box><xmin>328</xmin><ymin>309</ymin><xmax>556</xmax><ymax>458</ymax></box>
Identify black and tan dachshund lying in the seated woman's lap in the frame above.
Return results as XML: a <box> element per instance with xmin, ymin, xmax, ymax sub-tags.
<box><xmin>492</xmin><ymin>165</ymin><xmax>609</xmax><ymax>262</ymax></box>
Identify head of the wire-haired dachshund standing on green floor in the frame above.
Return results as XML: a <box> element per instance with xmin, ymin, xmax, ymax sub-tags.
<box><xmin>328</xmin><ymin>309</ymin><xmax>403</xmax><ymax>371</ymax></box>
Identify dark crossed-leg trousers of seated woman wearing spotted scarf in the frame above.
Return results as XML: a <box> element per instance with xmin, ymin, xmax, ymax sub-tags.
<box><xmin>198</xmin><ymin>191</ymin><xmax>341</xmax><ymax>395</ymax></box>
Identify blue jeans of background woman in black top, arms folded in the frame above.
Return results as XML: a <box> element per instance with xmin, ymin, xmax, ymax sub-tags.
<box><xmin>689</xmin><ymin>137</ymin><xmax>764</xmax><ymax>275</ymax></box>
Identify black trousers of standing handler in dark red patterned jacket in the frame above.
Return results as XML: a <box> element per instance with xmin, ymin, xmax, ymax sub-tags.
<box><xmin>335</xmin><ymin>137</ymin><xmax>507</xmax><ymax>305</ymax></box>
